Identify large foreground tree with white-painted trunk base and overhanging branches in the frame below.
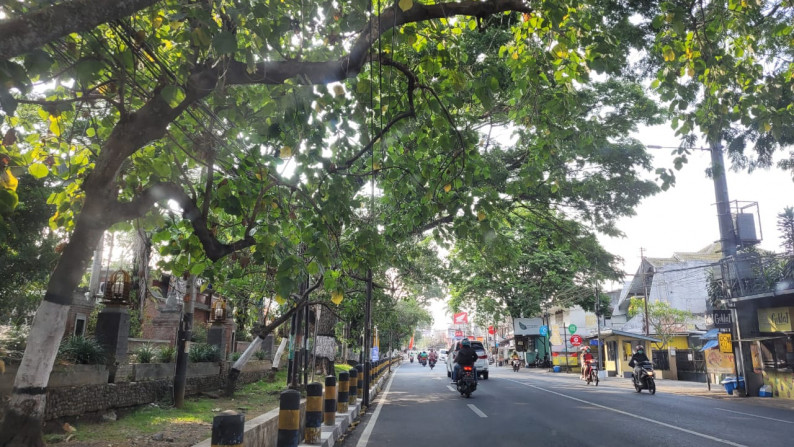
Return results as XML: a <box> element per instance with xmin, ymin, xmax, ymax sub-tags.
<box><xmin>0</xmin><ymin>0</ymin><xmax>712</xmax><ymax>445</ymax></box>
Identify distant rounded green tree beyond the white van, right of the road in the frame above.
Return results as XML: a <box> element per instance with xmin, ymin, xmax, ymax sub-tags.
<box><xmin>449</xmin><ymin>212</ymin><xmax>620</xmax><ymax>321</ymax></box>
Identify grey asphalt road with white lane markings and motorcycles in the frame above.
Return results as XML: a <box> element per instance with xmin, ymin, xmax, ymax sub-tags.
<box><xmin>342</xmin><ymin>363</ymin><xmax>794</xmax><ymax>447</ymax></box>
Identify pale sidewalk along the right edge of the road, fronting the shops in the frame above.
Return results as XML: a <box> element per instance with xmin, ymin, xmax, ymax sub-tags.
<box><xmin>516</xmin><ymin>368</ymin><xmax>794</xmax><ymax>410</ymax></box>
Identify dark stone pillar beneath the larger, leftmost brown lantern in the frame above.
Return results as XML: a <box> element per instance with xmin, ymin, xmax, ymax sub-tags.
<box><xmin>96</xmin><ymin>303</ymin><xmax>130</xmax><ymax>383</ymax></box>
